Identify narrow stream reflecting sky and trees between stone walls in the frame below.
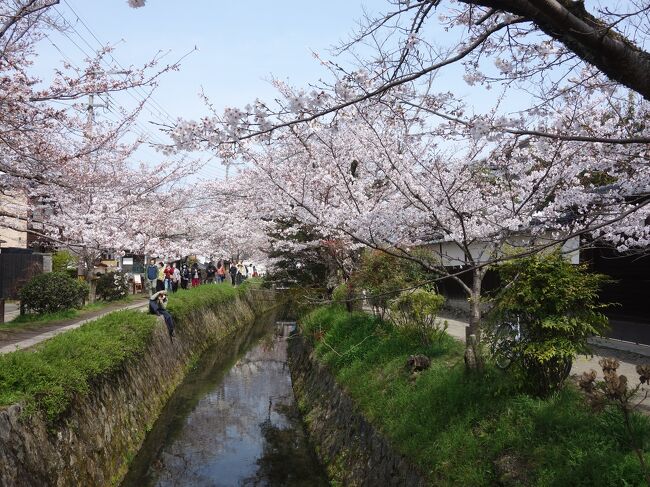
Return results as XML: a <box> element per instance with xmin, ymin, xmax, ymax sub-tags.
<box><xmin>122</xmin><ymin>318</ymin><xmax>328</xmax><ymax>487</ymax></box>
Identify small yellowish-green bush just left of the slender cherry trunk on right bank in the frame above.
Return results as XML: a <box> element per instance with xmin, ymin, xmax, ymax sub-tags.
<box><xmin>390</xmin><ymin>289</ymin><xmax>447</xmax><ymax>344</ymax></box>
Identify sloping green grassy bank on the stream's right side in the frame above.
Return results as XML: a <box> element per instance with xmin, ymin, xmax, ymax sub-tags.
<box><xmin>303</xmin><ymin>307</ymin><xmax>650</xmax><ymax>486</ymax></box>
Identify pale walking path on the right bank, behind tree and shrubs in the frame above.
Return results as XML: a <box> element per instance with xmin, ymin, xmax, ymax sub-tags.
<box><xmin>439</xmin><ymin>317</ymin><xmax>650</xmax><ymax>387</ymax></box>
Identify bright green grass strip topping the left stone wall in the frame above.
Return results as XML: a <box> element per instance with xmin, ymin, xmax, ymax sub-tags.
<box><xmin>0</xmin><ymin>285</ymin><xmax>247</xmax><ymax>421</ymax></box>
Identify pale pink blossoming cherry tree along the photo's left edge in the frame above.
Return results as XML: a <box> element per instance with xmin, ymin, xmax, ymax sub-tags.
<box><xmin>0</xmin><ymin>0</ymin><xmax>196</xmax><ymax>277</ymax></box>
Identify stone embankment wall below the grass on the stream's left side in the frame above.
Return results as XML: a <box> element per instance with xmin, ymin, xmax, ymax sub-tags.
<box><xmin>0</xmin><ymin>291</ymin><xmax>272</xmax><ymax>487</ymax></box>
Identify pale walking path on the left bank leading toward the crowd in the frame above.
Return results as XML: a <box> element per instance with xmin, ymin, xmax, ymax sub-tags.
<box><xmin>0</xmin><ymin>299</ymin><xmax>149</xmax><ymax>354</ymax></box>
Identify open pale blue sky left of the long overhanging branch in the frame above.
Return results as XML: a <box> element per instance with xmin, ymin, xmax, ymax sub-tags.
<box><xmin>36</xmin><ymin>0</ymin><xmax>386</xmax><ymax>177</ymax></box>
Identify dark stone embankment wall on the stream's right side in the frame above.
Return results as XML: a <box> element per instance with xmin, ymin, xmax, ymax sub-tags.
<box><xmin>289</xmin><ymin>335</ymin><xmax>430</xmax><ymax>487</ymax></box>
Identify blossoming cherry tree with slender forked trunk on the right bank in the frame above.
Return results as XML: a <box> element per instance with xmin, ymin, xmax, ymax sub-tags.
<box><xmin>196</xmin><ymin>89</ymin><xmax>650</xmax><ymax>340</ymax></box>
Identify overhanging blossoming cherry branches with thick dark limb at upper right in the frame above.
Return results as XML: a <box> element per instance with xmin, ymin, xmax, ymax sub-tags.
<box><xmin>168</xmin><ymin>1</ymin><xmax>650</xmax><ymax>278</ymax></box>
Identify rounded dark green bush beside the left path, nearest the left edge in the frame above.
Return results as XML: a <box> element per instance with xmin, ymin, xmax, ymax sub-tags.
<box><xmin>19</xmin><ymin>272</ymin><xmax>89</xmax><ymax>313</ymax></box>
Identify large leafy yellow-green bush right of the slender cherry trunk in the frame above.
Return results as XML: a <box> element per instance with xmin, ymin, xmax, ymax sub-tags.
<box><xmin>487</xmin><ymin>253</ymin><xmax>608</xmax><ymax>395</ymax></box>
